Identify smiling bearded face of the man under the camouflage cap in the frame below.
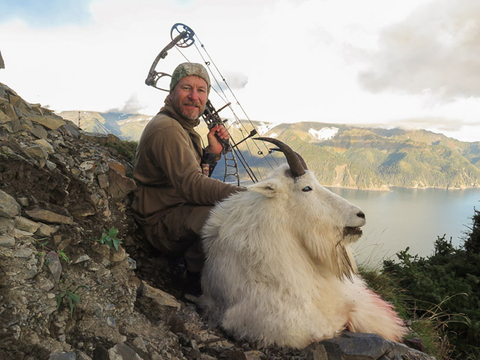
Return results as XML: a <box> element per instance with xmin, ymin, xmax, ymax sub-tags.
<box><xmin>171</xmin><ymin>75</ymin><xmax>208</xmax><ymax>120</ymax></box>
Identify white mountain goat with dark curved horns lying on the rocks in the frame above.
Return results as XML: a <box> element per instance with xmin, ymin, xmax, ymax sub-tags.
<box><xmin>201</xmin><ymin>138</ymin><xmax>406</xmax><ymax>348</ymax></box>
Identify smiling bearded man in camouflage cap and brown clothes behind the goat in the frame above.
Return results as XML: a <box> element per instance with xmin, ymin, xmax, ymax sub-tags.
<box><xmin>132</xmin><ymin>63</ymin><xmax>245</xmax><ymax>274</ymax></box>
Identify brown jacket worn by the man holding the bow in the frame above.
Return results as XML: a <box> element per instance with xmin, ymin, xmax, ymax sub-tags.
<box><xmin>132</xmin><ymin>97</ymin><xmax>244</xmax><ymax>225</ymax></box>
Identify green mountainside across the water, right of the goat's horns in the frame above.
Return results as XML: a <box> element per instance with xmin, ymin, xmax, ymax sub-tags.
<box><xmin>255</xmin><ymin>123</ymin><xmax>480</xmax><ymax>189</ymax></box>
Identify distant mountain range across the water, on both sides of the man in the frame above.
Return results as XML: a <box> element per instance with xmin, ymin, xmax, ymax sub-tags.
<box><xmin>59</xmin><ymin>111</ymin><xmax>480</xmax><ymax>190</ymax></box>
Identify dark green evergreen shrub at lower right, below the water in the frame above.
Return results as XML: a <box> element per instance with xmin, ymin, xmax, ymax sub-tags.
<box><xmin>382</xmin><ymin>210</ymin><xmax>480</xmax><ymax>359</ymax></box>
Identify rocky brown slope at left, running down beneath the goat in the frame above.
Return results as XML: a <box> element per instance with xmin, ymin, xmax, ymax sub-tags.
<box><xmin>0</xmin><ymin>84</ymin><xmax>436</xmax><ymax>360</ymax></box>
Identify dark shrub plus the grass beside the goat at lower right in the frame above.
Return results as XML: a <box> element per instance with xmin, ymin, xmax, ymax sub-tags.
<box><xmin>362</xmin><ymin>210</ymin><xmax>480</xmax><ymax>359</ymax></box>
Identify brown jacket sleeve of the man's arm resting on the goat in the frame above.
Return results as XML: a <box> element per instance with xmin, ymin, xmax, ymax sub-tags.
<box><xmin>150</xmin><ymin>125</ymin><xmax>245</xmax><ymax>205</ymax></box>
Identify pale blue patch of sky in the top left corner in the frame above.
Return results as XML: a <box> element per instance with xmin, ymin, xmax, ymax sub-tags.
<box><xmin>0</xmin><ymin>0</ymin><xmax>92</xmax><ymax>28</ymax></box>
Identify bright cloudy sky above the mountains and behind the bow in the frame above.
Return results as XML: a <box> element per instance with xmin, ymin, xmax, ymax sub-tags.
<box><xmin>0</xmin><ymin>0</ymin><xmax>480</xmax><ymax>141</ymax></box>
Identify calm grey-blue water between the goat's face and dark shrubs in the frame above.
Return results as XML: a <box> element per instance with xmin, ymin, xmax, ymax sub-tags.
<box><xmin>330</xmin><ymin>188</ymin><xmax>480</xmax><ymax>267</ymax></box>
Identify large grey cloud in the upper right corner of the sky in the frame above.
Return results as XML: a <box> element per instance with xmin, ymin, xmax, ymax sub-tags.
<box><xmin>358</xmin><ymin>0</ymin><xmax>480</xmax><ymax>102</ymax></box>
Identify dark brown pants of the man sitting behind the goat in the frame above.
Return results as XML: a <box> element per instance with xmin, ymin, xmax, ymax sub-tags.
<box><xmin>145</xmin><ymin>205</ymin><xmax>213</xmax><ymax>272</ymax></box>
